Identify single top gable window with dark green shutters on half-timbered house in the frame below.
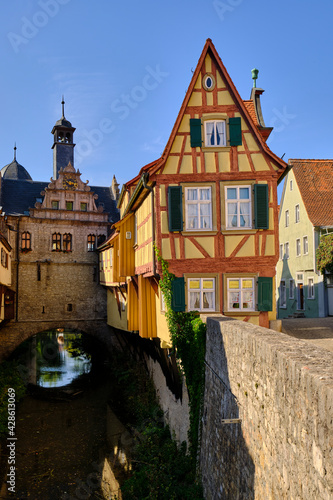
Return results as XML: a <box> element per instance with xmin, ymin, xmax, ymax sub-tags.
<box><xmin>190</xmin><ymin>114</ymin><xmax>242</xmax><ymax>148</ymax></box>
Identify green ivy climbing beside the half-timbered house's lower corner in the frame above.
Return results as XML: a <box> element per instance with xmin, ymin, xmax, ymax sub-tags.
<box><xmin>155</xmin><ymin>247</ymin><xmax>206</xmax><ymax>459</ymax></box>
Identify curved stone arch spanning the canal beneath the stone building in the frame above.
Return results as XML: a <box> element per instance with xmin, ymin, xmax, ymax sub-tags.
<box><xmin>0</xmin><ymin>320</ymin><xmax>117</xmax><ymax>362</ymax></box>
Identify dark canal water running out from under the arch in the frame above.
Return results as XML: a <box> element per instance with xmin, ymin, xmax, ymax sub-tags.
<box><xmin>0</xmin><ymin>330</ymin><xmax>131</xmax><ymax>500</ymax></box>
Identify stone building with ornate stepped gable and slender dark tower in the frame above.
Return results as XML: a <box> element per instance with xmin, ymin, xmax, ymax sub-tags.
<box><xmin>0</xmin><ymin>102</ymin><xmax>119</xmax><ymax>324</ymax></box>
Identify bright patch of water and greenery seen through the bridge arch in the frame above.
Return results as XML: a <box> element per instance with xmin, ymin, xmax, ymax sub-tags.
<box><xmin>34</xmin><ymin>331</ymin><xmax>91</xmax><ymax>388</ymax></box>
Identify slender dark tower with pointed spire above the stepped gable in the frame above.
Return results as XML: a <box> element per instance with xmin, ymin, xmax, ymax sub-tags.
<box><xmin>51</xmin><ymin>96</ymin><xmax>75</xmax><ymax>179</ymax></box>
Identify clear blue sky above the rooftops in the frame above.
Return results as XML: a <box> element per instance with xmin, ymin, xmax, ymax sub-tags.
<box><xmin>0</xmin><ymin>0</ymin><xmax>333</xmax><ymax>201</ymax></box>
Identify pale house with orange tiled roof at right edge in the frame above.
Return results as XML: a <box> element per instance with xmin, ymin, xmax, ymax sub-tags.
<box><xmin>277</xmin><ymin>159</ymin><xmax>333</xmax><ymax>318</ymax></box>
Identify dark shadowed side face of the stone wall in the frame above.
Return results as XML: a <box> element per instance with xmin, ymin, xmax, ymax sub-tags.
<box><xmin>200</xmin><ymin>319</ymin><xmax>255</xmax><ymax>500</ymax></box>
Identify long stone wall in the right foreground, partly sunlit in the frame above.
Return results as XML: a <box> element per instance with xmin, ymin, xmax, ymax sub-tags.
<box><xmin>200</xmin><ymin>318</ymin><xmax>333</xmax><ymax>500</ymax></box>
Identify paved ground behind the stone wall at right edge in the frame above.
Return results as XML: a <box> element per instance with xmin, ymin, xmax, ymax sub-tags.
<box><xmin>282</xmin><ymin>317</ymin><xmax>333</xmax><ymax>352</ymax></box>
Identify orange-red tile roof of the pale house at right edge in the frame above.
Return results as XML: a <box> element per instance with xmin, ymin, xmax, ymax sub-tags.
<box><xmin>289</xmin><ymin>159</ymin><xmax>333</xmax><ymax>226</ymax></box>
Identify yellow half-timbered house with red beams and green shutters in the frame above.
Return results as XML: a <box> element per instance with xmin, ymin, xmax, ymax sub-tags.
<box><xmin>100</xmin><ymin>39</ymin><xmax>286</xmax><ymax>346</ymax></box>
